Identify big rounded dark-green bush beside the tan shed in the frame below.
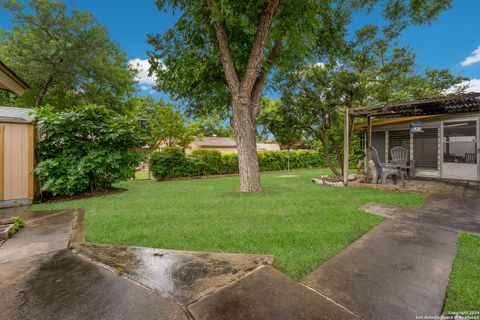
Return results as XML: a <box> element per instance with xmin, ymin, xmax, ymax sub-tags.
<box><xmin>34</xmin><ymin>105</ymin><xmax>139</xmax><ymax>195</ymax></box>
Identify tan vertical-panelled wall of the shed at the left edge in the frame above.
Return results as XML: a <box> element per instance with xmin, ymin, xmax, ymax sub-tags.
<box><xmin>0</xmin><ymin>122</ymin><xmax>34</xmax><ymax>201</ymax></box>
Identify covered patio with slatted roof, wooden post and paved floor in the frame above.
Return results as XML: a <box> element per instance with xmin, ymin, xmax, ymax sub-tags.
<box><xmin>344</xmin><ymin>93</ymin><xmax>480</xmax><ymax>192</ymax></box>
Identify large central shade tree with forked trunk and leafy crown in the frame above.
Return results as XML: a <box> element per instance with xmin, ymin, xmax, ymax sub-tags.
<box><xmin>149</xmin><ymin>0</ymin><xmax>451</xmax><ymax>192</ymax></box>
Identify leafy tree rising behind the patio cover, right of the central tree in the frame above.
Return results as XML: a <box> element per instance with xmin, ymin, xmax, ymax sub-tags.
<box><xmin>260</xmin><ymin>25</ymin><xmax>465</xmax><ymax>174</ymax></box>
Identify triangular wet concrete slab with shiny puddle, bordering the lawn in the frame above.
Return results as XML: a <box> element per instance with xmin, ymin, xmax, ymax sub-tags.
<box><xmin>74</xmin><ymin>243</ymin><xmax>273</xmax><ymax>305</ymax></box>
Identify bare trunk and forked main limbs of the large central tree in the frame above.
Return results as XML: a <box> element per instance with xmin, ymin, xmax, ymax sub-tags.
<box><xmin>205</xmin><ymin>0</ymin><xmax>282</xmax><ymax>192</ymax></box>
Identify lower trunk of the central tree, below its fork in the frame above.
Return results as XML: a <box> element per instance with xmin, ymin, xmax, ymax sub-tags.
<box><xmin>232</xmin><ymin>102</ymin><xmax>262</xmax><ymax>192</ymax></box>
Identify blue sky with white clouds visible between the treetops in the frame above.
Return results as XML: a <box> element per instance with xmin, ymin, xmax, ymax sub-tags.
<box><xmin>0</xmin><ymin>0</ymin><xmax>480</xmax><ymax>96</ymax></box>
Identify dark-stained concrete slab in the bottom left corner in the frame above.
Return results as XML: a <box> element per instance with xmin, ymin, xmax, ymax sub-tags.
<box><xmin>0</xmin><ymin>249</ymin><xmax>187</xmax><ymax>320</ymax></box>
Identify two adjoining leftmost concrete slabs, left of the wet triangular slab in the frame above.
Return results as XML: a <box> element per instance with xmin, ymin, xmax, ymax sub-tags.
<box><xmin>0</xmin><ymin>211</ymin><xmax>188</xmax><ymax>320</ymax></box>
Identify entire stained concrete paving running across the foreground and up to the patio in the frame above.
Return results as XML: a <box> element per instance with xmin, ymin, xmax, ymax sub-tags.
<box><xmin>0</xmin><ymin>196</ymin><xmax>480</xmax><ymax>320</ymax></box>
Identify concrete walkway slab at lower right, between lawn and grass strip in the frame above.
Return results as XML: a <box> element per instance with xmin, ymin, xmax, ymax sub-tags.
<box><xmin>301</xmin><ymin>210</ymin><xmax>457</xmax><ymax>320</ymax></box>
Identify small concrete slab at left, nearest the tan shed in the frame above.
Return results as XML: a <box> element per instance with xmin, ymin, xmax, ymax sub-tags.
<box><xmin>0</xmin><ymin>210</ymin><xmax>73</xmax><ymax>263</ymax></box>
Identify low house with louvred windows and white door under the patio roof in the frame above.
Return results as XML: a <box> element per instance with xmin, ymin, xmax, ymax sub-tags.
<box><xmin>353</xmin><ymin>93</ymin><xmax>480</xmax><ymax>181</ymax></box>
